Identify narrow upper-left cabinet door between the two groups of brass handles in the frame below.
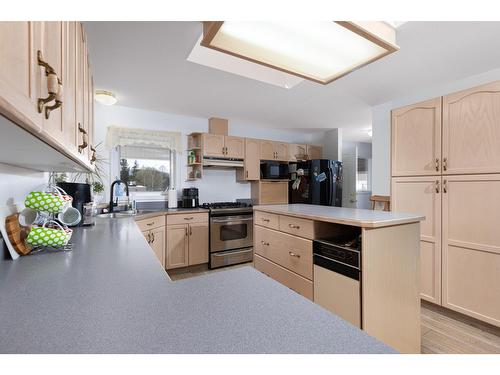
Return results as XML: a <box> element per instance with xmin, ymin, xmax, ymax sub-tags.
<box><xmin>62</xmin><ymin>22</ymin><xmax>78</xmax><ymax>154</ymax></box>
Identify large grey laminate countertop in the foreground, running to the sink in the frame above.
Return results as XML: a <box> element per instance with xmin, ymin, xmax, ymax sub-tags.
<box><xmin>0</xmin><ymin>218</ymin><xmax>395</xmax><ymax>353</ymax></box>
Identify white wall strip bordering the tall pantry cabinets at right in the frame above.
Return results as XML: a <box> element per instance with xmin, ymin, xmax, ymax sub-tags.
<box><xmin>372</xmin><ymin>68</ymin><xmax>500</xmax><ymax>195</ymax></box>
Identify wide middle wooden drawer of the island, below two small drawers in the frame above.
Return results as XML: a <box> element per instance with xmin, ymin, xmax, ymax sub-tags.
<box><xmin>254</xmin><ymin>226</ymin><xmax>313</xmax><ymax>280</ymax></box>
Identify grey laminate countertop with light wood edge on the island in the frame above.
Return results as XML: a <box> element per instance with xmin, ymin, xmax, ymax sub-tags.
<box><xmin>253</xmin><ymin>204</ymin><xmax>425</xmax><ymax>228</ymax></box>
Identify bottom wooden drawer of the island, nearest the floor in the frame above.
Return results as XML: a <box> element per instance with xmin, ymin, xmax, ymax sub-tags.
<box><xmin>254</xmin><ymin>254</ymin><xmax>313</xmax><ymax>300</ymax></box>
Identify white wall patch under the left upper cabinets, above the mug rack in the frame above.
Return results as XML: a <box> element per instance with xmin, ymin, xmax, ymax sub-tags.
<box><xmin>0</xmin><ymin>163</ymin><xmax>48</xmax><ymax>207</ymax></box>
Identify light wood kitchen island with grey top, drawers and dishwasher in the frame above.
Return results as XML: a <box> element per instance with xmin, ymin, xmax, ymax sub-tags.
<box><xmin>254</xmin><ymin>204</ymin><xmax>424</xmax><ymax>353</ymax></box>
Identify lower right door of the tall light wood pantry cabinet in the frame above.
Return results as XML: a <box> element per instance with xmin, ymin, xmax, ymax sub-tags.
<box><xmin>443</xmin><ymin>174</ymin><xmax>500</xmax><ymax>326</ymax></box>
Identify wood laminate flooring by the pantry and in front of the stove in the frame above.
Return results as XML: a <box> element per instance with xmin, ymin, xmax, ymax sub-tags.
<box><xmin>168</xmin><ymin>263</ymin><xmax>500</xmax><ymax>354</ymax></box>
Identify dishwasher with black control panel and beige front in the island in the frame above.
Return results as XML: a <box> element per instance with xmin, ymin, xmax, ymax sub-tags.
<box><xmin>313</xmin><ymin>236</ymin><xmax>362</xmax><ymax>328</ymax></box>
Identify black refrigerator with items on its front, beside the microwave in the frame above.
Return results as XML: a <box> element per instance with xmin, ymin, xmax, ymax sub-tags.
<box><xmin>288</xmin><ymin>159</ymin><xmax>342</xmax><ymax>207</ymax></box>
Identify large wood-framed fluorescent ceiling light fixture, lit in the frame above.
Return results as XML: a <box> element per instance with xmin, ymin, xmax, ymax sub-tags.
<box><xmin>201</xmin><ymin>21</ymin><xmax>399</xmax><ymax>84</ymax></box>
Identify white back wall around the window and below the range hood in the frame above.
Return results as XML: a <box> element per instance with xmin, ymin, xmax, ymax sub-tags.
<box><xmin>94</xmin><ymin>104</ymin><xmax>312</xmax><ymax>203</ymax></box>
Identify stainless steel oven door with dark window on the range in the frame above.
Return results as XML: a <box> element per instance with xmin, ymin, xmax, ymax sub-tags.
<box><xmin>210</xmin><ymin>215</ymin><xmax>253</xmax><ymax>253</ymax></box>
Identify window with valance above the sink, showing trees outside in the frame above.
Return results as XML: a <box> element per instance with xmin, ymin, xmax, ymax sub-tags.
<box><xmin>119</xmin><ymin>146</ymin><xmax>173</xmax><ymax>193</ymax></box>
